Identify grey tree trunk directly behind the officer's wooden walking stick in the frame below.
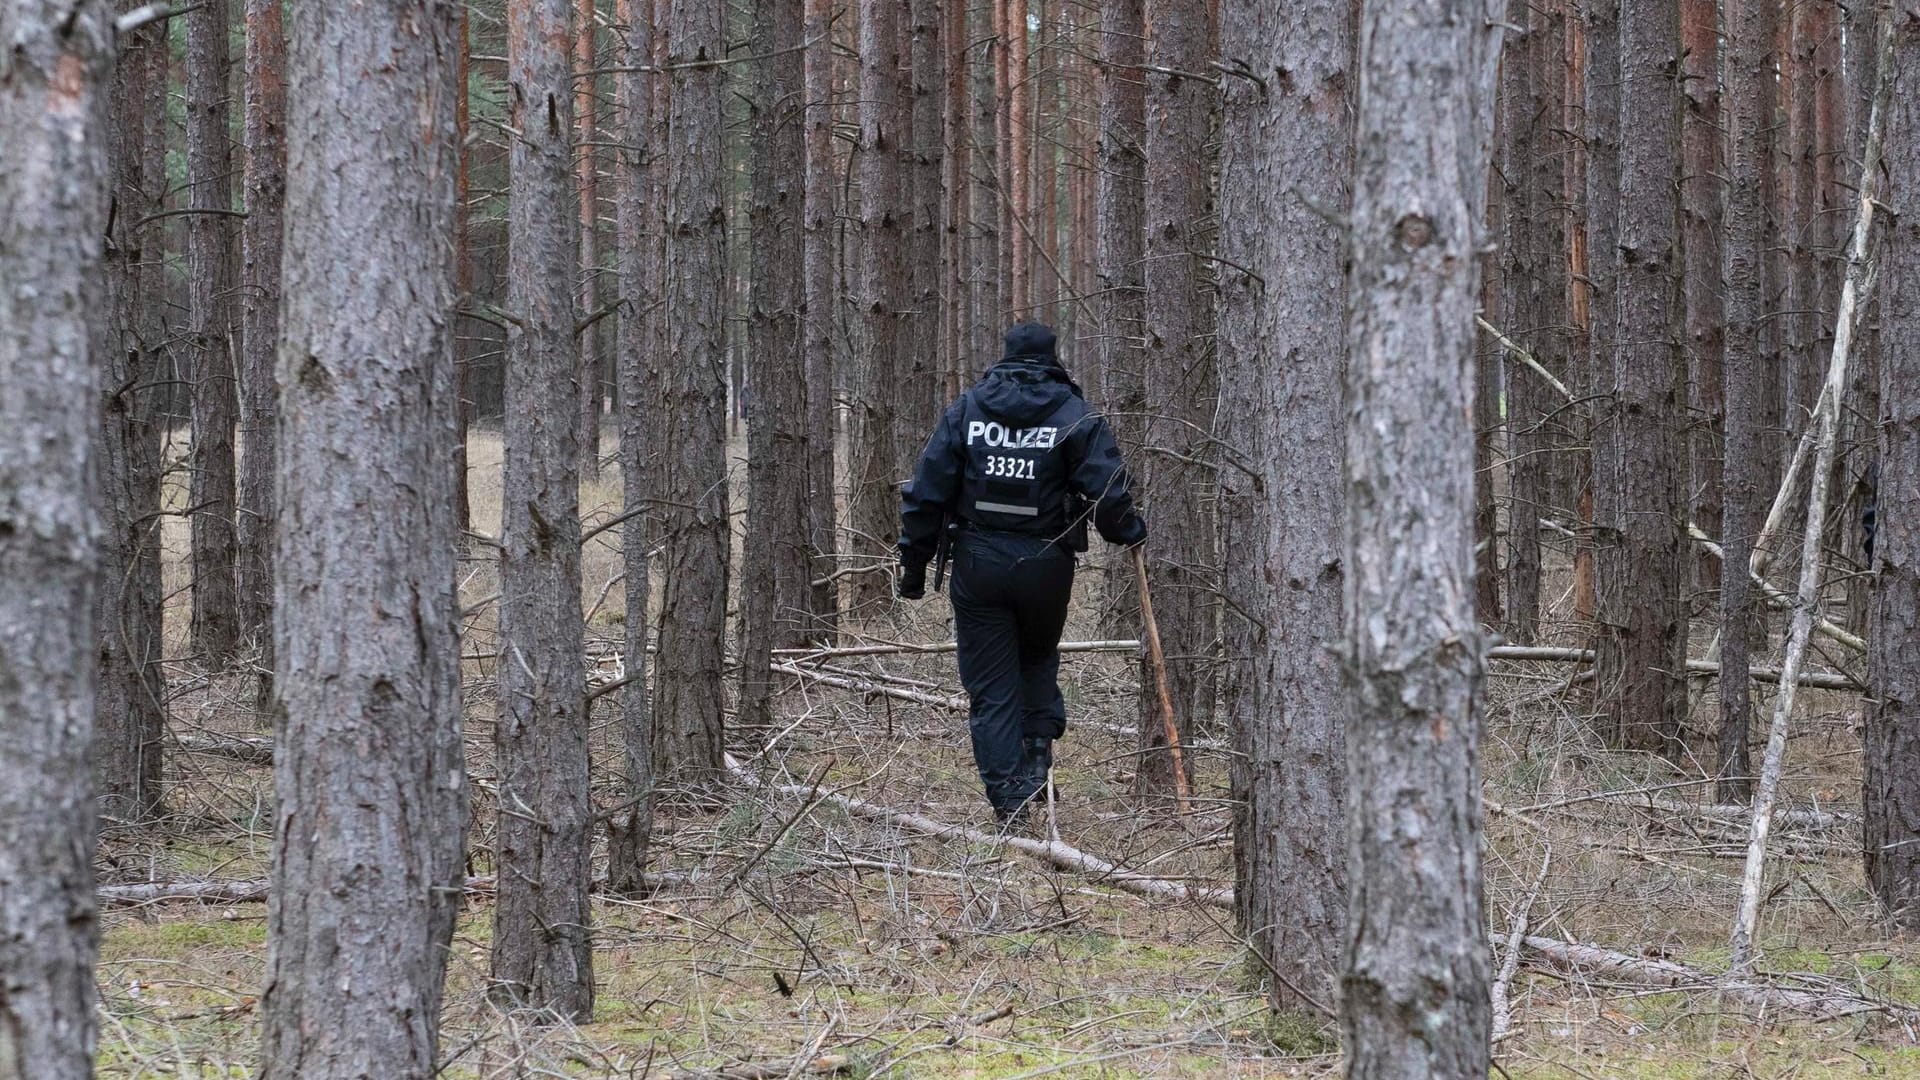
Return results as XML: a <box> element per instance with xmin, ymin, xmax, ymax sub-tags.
<box><xmin>1133</xmin><ymin>0</ymin><xmax>1217</xmax><ymax>794</ymax></box>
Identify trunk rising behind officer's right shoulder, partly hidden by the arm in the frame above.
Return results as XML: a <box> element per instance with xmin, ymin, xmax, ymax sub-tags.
<box><xmin>1094</xmin><ymin>0</ymin><xmax>1146</xmax><ymax>636</ymax></box>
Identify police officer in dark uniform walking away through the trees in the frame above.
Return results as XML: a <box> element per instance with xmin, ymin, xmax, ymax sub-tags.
<box><xmin>899</xmin><ymin>323</ymin><xmax>1146</xmax><ymax>826</ymax></box>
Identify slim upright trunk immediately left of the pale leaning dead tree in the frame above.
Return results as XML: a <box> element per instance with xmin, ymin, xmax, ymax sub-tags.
<box><xmin>1716</xmin><ymin>0</ymin><xmax>1774</xmax><ymax>803</ymax></box>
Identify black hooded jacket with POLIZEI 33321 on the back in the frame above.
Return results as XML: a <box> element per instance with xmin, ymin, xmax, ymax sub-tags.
<box><xmin>900</xmin><ymin>356</ymin><xmax>1146</xmax><ymax>567</ymax></box>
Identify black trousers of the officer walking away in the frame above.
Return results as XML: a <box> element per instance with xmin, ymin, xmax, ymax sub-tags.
<box><xmin>952</xmin><ymin>528</ymin><xmax>1073</xmax><ymax>811</ymax></box>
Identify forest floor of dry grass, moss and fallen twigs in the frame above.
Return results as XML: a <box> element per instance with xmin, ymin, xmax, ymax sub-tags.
<box><xmin>100</xmin><ymin>424</ymin><xmax>1920</xmax><ymax>1080</ymax></box>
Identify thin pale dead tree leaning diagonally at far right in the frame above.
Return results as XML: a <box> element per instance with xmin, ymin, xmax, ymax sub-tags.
<box><xmin>1728</xmin><ymin>0</ymin><xmax>1893</xmax><ymax>976</ymax></box>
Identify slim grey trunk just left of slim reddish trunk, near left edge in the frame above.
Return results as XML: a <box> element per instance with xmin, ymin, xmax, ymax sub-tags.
<box><xmin>184</xmin><ymin>0</ymin><xmax>242</xmax><ymax>667</ymax></box>
